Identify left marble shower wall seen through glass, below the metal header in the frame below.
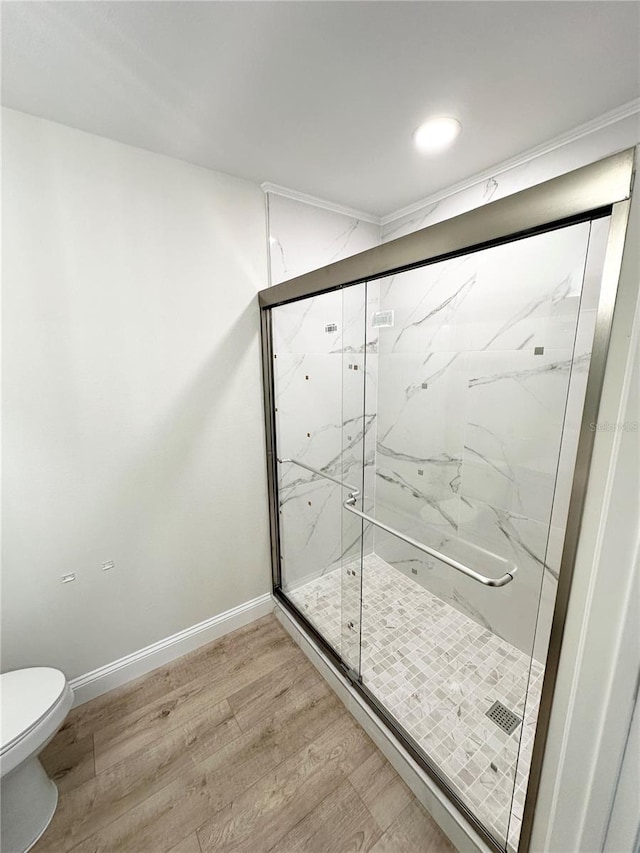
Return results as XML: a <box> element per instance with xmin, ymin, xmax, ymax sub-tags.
<box><xmin>272</xmin><ymin>285</ymin><xmax>377</xmax><ymax>614</ymax></box>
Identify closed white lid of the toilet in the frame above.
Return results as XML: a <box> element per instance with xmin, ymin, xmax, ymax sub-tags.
<box><xmin>0</xmin><ymin>666</ymin><xmax>67</xmax><ymax>751</ymax></box>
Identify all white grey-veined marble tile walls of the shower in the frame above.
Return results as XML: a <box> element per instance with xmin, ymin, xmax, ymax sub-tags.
<box><xmin>269</xmin><ymin>188</ymin><xmax>608</xmax><ymax>660</ymax></box>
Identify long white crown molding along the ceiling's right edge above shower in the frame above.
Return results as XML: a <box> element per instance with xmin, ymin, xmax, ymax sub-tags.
<box><xmin>380</xmin><ymin>98</ymin><xmax>640</xmax><ymax>226</ymax></box>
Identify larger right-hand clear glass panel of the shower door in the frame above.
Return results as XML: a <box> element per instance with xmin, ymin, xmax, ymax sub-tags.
<box><xmin>361</xmin><ymin>220</ymin><xmax>608</xmax><ymax>850</ymax></box>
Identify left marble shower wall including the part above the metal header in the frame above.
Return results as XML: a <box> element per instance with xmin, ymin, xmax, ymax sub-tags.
<box><xmin>267</xmin><ymin>192</ymin><xmax>380</xmax><ymax>617</ymax></box>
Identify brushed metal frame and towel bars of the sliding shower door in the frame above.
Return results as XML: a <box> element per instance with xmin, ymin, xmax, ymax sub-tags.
<box><xmin>259</xmin><ymin>149</ymin><xmax>637</xmax><ymax>853</ymax></box>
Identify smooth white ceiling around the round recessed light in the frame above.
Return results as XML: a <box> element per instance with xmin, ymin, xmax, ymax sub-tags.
<box><xmin>2</xmin><ymin>0</ymin><xmax>640</xmax><ymax>214</ymax></box>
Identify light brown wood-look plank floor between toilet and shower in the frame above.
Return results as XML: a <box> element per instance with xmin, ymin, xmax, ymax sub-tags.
<box><xmin>33</xmin><ymin>616</ymin><xmax>454</xmax><ymax>853</ymax></box>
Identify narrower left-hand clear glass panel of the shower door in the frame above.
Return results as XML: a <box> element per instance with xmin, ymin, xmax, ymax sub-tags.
<box><xmin>271</xmin><ymin>284</ymin><xmax>375</xmax><ymax>678</ymax></box>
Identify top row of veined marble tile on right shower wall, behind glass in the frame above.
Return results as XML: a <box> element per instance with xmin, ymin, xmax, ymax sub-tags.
<box><xmin>379</xmin><ymin>223</ymin><xmax>589</xmax><ymax>353</ymax></box>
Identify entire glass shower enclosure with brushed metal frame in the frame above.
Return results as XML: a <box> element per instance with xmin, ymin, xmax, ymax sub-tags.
<box><xmin>260</xmin><ymin>152</ymin><xmax>633</xmax><ymax>851</ymax></box>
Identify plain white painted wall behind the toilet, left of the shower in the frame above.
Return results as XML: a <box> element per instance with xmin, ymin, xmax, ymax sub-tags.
<box><xmin>2</xmin><ymin>110</ymin><xmax>269</xmax><ymax>677</ymax></box>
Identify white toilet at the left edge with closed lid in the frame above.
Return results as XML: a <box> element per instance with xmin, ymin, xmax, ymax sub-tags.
<box><xmin>0</xmin><ymin>666</ymin><xmax>73</xmax><ymax>853</ymax></box>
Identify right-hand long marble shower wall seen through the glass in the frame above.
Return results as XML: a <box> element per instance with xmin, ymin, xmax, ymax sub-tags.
<box><xmin>374</xmin><ymin>220</ymin><xmax>608</xmax><ymax>660</ymax></box>
